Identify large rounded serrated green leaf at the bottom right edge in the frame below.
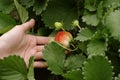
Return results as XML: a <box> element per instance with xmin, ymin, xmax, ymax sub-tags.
<box><xmin>83</xmin><ymin>56</ymin><xmax>113</xmax><ymax>80</ymax></box>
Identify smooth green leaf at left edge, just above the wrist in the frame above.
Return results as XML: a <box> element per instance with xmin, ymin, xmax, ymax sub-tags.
<box><xmin>0</xmin><ymin>13</ymin><xmax>16</xmax><ymax>34</ymax></box>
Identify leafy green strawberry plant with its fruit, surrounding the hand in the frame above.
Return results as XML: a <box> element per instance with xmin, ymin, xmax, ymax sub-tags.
<box><xmin>0</xmin><ymin>0</ymin><xmax>120</xmax><ymax>80</ymax></box>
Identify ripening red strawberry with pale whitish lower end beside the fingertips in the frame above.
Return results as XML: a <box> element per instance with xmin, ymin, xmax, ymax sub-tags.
<box><xmin>55</xmin><ymin>31</ymin><xmax>73</xmax><ymax>47</ymax></box>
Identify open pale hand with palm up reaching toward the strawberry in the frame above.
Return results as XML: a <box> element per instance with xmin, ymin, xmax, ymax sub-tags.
<box><xmin>0</xmin><ymin>19</ymin><xmax>50</xmax><ymax>68</ymax></box>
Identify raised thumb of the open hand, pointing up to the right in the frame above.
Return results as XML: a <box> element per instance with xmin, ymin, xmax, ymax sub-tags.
<box><xmin>21</xmin><ymin>19</ymin><xmax>35</xmax><ymax>32</ymax></box>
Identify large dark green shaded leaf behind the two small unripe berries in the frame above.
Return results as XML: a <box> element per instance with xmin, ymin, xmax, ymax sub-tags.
<box><xmin>42</xmin><ymin>0</ymin><xmax>78</xmax><ymax>30</ymax></box>
